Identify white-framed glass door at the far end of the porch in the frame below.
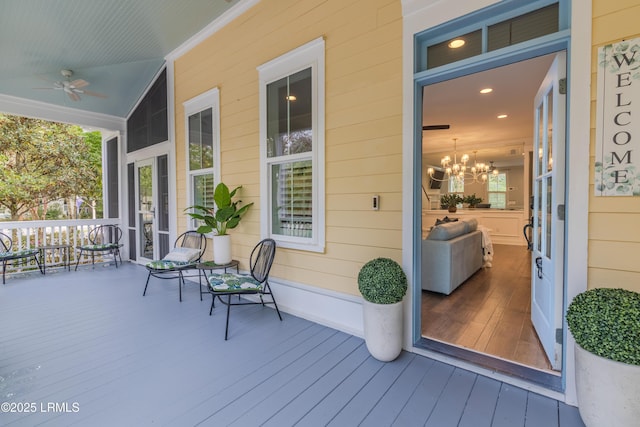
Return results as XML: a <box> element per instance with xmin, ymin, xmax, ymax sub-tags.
<box><xmin>136</xmin><ymin>159</ymin><xmax>158</xmax><ymax>262</ymax></box>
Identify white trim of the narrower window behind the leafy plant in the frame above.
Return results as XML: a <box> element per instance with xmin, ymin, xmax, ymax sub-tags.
<box><xmin>182</xmin><ymin>88</ymin><xmax>220</xmax><ymax>229</ymax></box>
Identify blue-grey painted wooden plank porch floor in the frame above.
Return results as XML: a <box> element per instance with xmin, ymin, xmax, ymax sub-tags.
<box><xmin>0</xmin><ymin>263</ymin><xmax>583</xmax><ymax>427</ymax></box>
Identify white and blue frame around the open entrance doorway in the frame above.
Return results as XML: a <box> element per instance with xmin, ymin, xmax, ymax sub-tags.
<box><xmin>402</xmin><ymin>0</ymin><xmax>592</xmax><ymax>404</ymax></box>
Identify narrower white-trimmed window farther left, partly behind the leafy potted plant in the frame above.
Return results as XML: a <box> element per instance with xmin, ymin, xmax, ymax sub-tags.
<box><xmin>183</xmin><ymin>89</ymin><xmax>220</xmax><ymax>228</ymax></box>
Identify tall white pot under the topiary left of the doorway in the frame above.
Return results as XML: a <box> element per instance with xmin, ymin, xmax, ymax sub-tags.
<box><xmin>362</xmin><ymin>300</ymin><xmax>403</xmax><ymax>362</ymax></box>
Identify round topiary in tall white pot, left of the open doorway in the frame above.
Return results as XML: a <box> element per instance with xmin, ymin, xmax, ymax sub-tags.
<box><xmin>358</xmin><ymin>258</ymin><xmax>407</xmax><ymax>362</ymax></box>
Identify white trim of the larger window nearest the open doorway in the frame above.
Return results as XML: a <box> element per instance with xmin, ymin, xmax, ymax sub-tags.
<box><xmin>258</xmin><ymin>37</ymin><xmax>325</xmax><ymax>252</ymax></box>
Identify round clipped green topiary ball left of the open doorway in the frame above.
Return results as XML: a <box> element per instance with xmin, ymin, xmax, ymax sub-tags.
<box><xmin>358</xmin><ymin>258</ymin><xmax>407</xmax><ymax>304</ymax></box>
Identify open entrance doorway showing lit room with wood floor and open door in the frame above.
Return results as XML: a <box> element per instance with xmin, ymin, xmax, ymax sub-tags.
<box><xmin>420</xmin><ymin>52</ymin><xmax>566</xmax><ymax>389</ymax></box>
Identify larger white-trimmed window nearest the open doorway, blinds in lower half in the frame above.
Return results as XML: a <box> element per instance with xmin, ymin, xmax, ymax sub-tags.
<box><xmin>258</xmin><ymin>39</ymin><xmax>324</xmax><ymax>252</ymax></box>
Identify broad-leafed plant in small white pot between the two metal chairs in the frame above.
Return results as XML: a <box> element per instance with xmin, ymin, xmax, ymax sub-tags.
<box><xmin>186</xmin><ymin>182</ymin><xmax>253</xmax><ymax>265</ymax></box>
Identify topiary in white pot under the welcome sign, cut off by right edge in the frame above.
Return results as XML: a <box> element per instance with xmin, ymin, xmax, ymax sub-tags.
<box><xmin>566</xmin><ymin>288</ymin><xmax>640</xmax><ymax>427</ymax></box>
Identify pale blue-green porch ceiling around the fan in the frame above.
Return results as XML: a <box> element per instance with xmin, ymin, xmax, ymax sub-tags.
<box><xmin>0</xmin><ymin>0</ymin><xmax>243</xmax><ymax>117</ymax></box>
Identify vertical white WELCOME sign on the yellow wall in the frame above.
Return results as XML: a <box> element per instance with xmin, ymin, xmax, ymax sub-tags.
<box><xmin>595</xmin><ymin>38</ymin><xmax>640</xmax><ymax>196</ymax></box>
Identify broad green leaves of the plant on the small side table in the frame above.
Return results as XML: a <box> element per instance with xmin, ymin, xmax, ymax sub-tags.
<box><xmin>185</xmin><ymin>182</ymin><xmax>253</xmax><ymax>236</ymax></box>
